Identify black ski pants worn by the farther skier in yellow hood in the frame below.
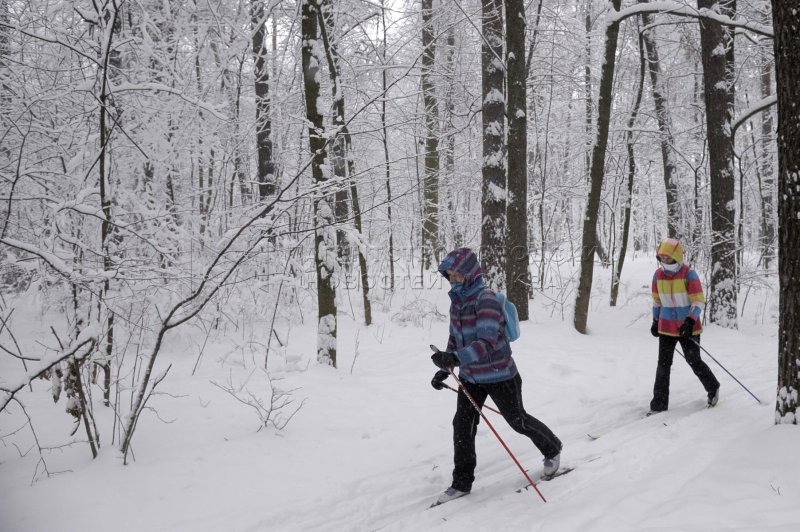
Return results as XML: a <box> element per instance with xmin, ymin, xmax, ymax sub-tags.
<box><xmin>650</xmin><ymin>334</ymin><xmax>719</xmax><ymax>412</ymax></box>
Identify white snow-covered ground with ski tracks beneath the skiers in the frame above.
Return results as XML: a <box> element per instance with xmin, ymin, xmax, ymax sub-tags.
<box><xmin>0</xmin><ymin>259</ymin><xmax>800</xmax><ymax>532</ymax></box>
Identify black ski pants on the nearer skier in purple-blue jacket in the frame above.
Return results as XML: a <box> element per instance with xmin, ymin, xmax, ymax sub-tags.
<box><xmin>453</xmin><ymin>374</ymin><xmax>561</xmax><ymax>491</ymax></box>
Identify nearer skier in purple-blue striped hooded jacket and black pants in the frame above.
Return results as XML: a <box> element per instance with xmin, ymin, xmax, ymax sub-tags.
<box><xmin>431</xmin><ymin>248</ymin><xmax>562</xmax><ymax>505</ymax></box>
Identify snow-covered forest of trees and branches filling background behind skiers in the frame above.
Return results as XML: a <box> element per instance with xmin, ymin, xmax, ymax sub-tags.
<box><xmin>0</xmin><ymin>0</ymin><xmax>800</xmax><ymax>476</ymax></box>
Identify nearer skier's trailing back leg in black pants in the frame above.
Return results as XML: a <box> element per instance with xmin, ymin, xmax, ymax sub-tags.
<box><xmin>487</xmin><ymin>374</ymin><xmax>561</xmax><ymax>458</ymax></box>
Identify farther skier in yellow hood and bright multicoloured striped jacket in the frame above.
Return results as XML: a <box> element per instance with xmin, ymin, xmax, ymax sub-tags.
<box><xmin>648</xmin><ymin>238</ymin><xmax>719</xmax><ymax>415</ymax></box>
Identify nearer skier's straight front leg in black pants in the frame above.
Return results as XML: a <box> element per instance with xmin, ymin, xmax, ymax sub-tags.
<box><xmin>452</xmin><ymin>381</ymin><xmax>486</xmax><ymax>491</ymax></box>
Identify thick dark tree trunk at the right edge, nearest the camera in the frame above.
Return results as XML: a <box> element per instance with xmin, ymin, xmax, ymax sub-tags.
<box><xmin>772</xmin><ymin>0</ymin><xmax>800</xmax><ymax>425</ymax></box>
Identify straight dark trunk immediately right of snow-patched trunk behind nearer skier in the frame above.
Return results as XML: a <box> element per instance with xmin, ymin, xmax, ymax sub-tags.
<box><xmin>506</xmin><ymin>0</ymin><xmax>531</xmax><ymax>321</ymax></box>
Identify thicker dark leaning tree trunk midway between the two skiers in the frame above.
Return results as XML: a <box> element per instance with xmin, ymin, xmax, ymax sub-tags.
<box><xmin>574</xmin><ymin>0</ymin><xmax>622</xmax><ymax>334</ymax></box>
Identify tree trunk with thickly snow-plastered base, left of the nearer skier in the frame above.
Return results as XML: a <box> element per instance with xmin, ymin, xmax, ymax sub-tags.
<box><xmin>301</xmin><ymin>0</ymin><xmax>336</xmax><ymax>367</ymax></box>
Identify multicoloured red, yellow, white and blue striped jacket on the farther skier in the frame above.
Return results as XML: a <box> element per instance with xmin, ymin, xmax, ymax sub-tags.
<box><xmin>652</xmin><ymin>264</ymin><xmax>706</xmax><ymax>336</ymax></box>
